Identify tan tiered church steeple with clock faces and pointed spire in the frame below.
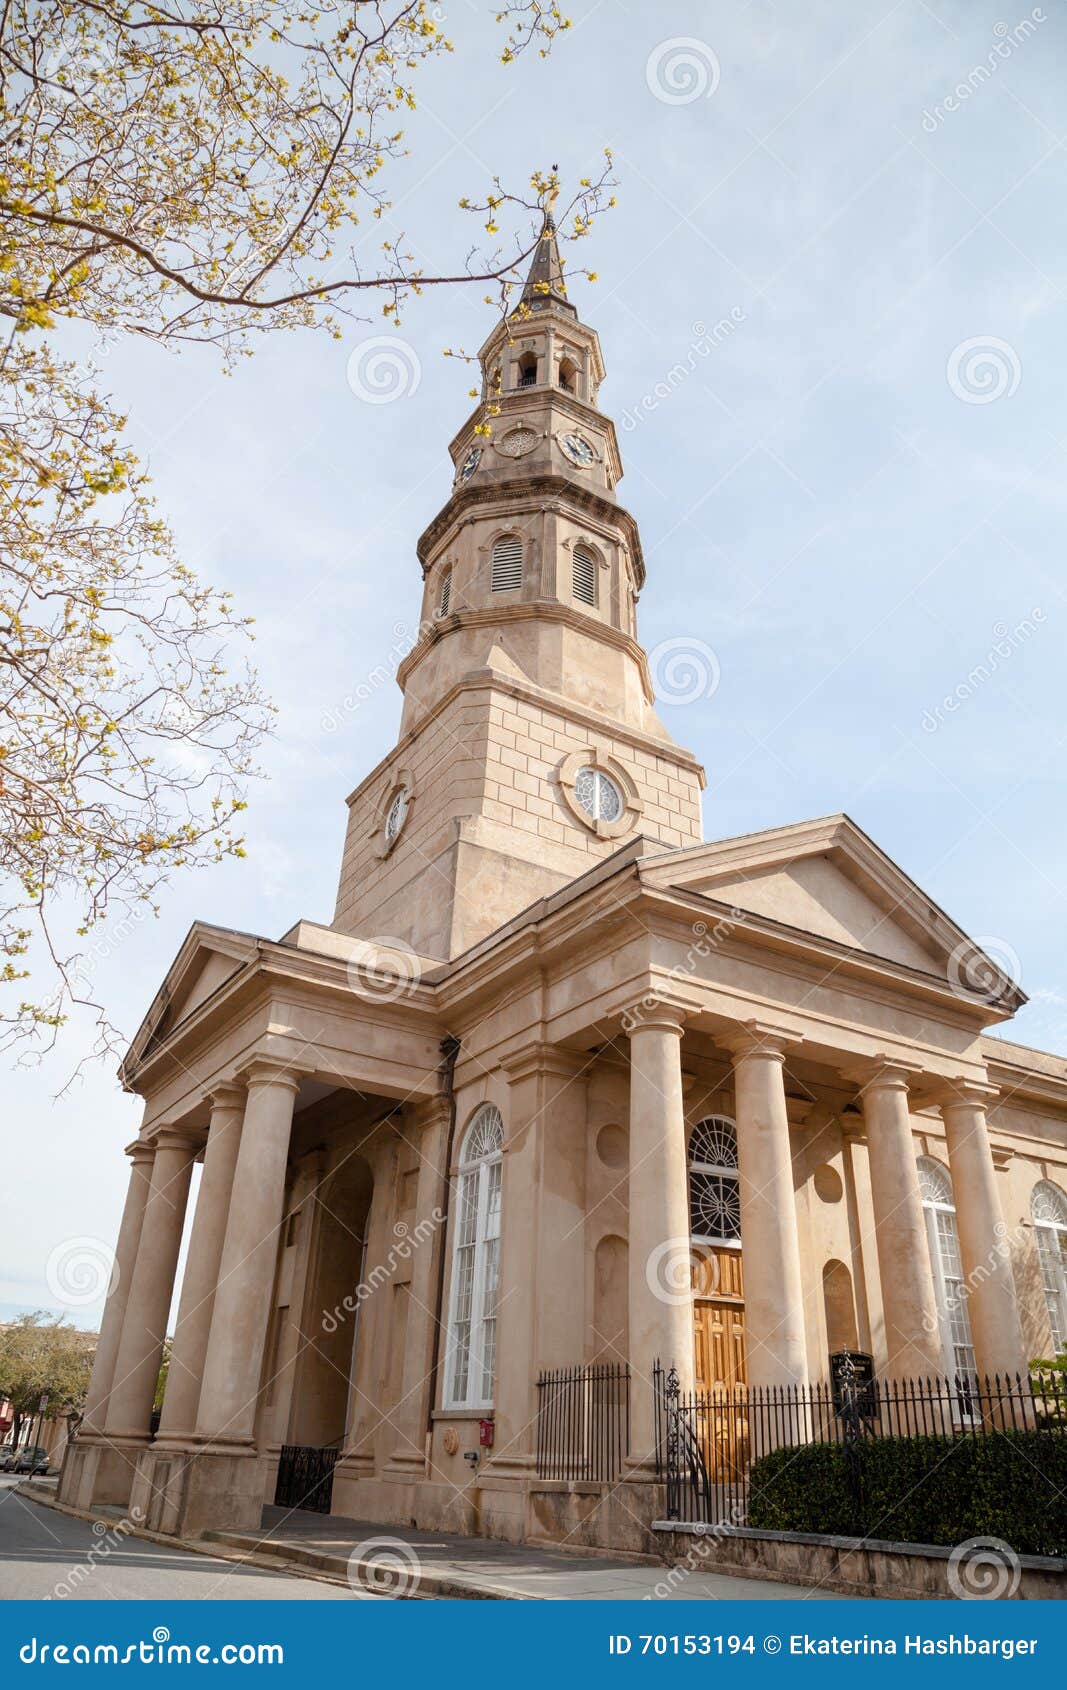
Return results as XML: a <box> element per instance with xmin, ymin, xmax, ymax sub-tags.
<box><xmin>333</xmin><ymin>229</ymin><xmax>703</xmax><ymax>960</ymax></box>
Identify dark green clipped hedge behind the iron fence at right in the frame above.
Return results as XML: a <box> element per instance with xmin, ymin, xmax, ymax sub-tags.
<box><xmin>747</xmin><ymin>1431</ymin><xmax>1067</xmax><ymax>1555</ymax></box>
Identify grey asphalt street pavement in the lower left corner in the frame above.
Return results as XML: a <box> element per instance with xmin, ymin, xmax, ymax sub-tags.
<box><xmin>0</xmin><ymin>1475</ymin><xmax>367</xmax><ymax>1602</ymax></box>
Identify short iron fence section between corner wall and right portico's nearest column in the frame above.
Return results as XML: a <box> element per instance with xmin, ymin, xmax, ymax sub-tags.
<box><xmin>538</xmin><ymin>1362</ymin><xmax>631</xmax><ymax>1484</ymax></box>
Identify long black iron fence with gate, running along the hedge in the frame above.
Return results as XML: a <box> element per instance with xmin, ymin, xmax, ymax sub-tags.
<box><xmin>653</xmin><ymin>1364</ymin><xmax>1067</xmax><ymax>1541</ymax></box>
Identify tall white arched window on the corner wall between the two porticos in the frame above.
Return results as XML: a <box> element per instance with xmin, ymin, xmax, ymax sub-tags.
<box><xmin>446</xmin><ymin>1104</ymin><xmax>504</xmax><ymax>1408</ymax></box>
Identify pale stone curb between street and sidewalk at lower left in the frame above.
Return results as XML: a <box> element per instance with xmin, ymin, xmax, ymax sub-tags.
<box><xmin>12</xmin><ymin>1482</ymin><xmax>534</xmax><ymax>1602</ymax></box>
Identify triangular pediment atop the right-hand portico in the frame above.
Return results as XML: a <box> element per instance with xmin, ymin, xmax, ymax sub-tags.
<box><xmin>641</xmin><ymin>815</ymin><xmax>1021</xmax><ymax>1002</ymax></box>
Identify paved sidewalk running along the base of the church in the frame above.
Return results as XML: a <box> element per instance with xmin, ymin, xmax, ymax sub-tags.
<box><xmin>19</xmin><ymin>1479</ymin><xmax>851</xmax><ymax>1602</ymax></box>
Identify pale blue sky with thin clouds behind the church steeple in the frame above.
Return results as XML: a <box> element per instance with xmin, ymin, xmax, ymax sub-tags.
<box><xmin>0</xmin><ymin>0</ymin><xmax>1067</xmax><ymax>1325</ymax></box>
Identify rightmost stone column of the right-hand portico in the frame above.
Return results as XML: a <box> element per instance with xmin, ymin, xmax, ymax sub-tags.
<box><xmin>942</xmin><ymin>1080</ymin><xmax>1028</xmax><ymax>1377</ymax></box>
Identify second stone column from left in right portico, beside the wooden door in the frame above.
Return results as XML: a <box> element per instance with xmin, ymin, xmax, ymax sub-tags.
<box><xmin>725</xmin><ymin>1022</ymin><xmax>808</xmax><ymax>1386</ymax></box>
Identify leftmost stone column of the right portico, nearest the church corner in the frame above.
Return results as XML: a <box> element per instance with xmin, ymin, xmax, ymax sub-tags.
<box><xmin>629</xmin><ymin>1004</ymin><xmax>693</xmax><ymax>1477</ymax></box>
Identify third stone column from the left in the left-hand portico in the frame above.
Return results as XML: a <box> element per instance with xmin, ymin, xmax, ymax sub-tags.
<box><xmin>159</xmin><ymin>1085</ymin><xmax>245</xmax><ymax>1438</ymax></box>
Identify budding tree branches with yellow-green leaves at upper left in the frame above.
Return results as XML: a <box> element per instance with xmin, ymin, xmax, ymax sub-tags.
<box><xmin>0</xmin><ymin>0</ymin><xmax>610</xmax><ymax>1048</ymax></box>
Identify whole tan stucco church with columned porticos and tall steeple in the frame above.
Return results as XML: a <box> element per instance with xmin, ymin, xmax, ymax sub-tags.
<box><xmin>61</xmin><ymin>218</ymin><xmax>1067</xmax><ymax>1548</ymax></box>
